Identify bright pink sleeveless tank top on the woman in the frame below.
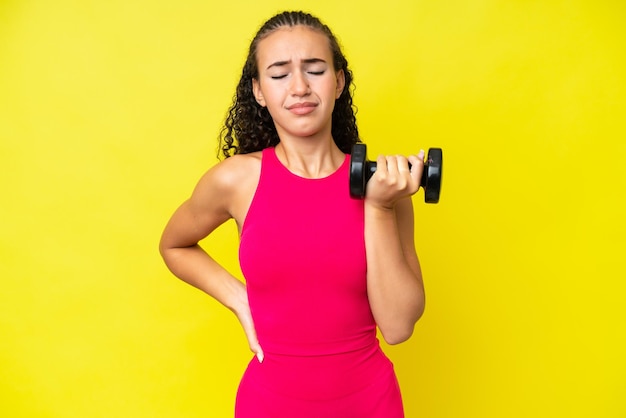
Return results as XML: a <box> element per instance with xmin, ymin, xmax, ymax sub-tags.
<box><xmin>239</xmin><ymin>148</ymin><xmax>378</xmax><ymax>356</ymax></box>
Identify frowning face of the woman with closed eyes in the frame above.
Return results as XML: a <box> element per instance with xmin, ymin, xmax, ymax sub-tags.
<box><xmin>252</xmin><ymin>26</ymin><xmax>345</xmax><ymax>140</ymax></box>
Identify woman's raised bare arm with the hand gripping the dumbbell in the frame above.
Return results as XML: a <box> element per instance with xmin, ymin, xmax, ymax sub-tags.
<box><xmin>365</xmin><ymin>158</ymin><xmax>425</xmax><ymax>344</ymax></box>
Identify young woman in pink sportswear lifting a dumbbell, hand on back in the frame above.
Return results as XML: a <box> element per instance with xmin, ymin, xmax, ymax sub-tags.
<box><xmin>160</xmin><ymin>12</ymin><xmax>424</xmax><ymax>418</ymax></box>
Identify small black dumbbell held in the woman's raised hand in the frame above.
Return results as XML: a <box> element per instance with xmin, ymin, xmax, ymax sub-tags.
<box><xmin>350</xmin><ymin>143</ymin><xmax>443</xmax><ymax>203</ymax></box>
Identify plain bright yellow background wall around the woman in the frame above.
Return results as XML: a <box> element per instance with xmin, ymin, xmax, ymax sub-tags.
<box><xmin>0</xmin><ymin>0</ymin><xmax>626</xmax><ymax>418</ymax></box>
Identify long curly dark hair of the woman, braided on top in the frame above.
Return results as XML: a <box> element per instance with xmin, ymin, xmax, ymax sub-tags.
<box><xmin>218</xmin><ymin>11</ymin><xmax>360</xmax><ymax>158</ymax></box>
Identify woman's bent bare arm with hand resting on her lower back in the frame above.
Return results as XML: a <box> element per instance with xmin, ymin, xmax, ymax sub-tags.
<box><xmin>159</xmin><ymin>157</ymin><xmax>263</xmax><ymax>360</ymax></box>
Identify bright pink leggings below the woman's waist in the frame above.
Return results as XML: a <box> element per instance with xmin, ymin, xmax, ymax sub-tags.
<box><xmin>235</xmin><ymin>346</ymin><xmax>404</xmax><ymax>418</ymax></box>
